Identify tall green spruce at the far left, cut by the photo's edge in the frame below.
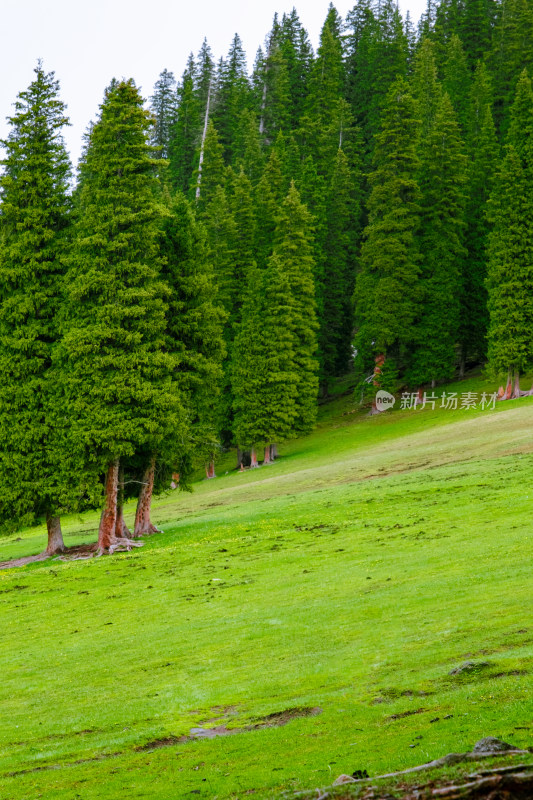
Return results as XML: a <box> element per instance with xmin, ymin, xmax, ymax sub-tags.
<box><xmin>0</xmin><ymin>63</ymin><xmax>74</xmax><ymax>554</ymax></box>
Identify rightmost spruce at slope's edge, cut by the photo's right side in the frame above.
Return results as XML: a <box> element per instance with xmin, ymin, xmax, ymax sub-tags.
<box><xmin>487</xmin><ymin>70</ymin><xmax>533</xmax><ymax>396</ymax></box>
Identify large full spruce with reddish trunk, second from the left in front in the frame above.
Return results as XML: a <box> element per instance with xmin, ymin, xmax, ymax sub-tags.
<box><xmin>59</xmin><ymin>80</ymin><xmax>183</xmax><ymax>553</ymax></box>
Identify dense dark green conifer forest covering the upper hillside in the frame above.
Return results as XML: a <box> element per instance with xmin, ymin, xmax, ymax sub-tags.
<box><xmin>0</xmin><ymin>0</ymin><xmax>533</xmax><ymax>555</ymax></box>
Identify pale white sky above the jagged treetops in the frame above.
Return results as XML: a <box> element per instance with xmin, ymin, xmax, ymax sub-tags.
<box><xmin>0</xmin><ymin>0</ymin><xmax>426</xmax><ymax>163</ymax></box>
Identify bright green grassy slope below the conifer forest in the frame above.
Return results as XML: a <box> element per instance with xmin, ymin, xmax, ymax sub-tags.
<box><xmin>0</xmin><ymin>379</ymin><xmax>533</xmax><ymax>800</ymax></box>
